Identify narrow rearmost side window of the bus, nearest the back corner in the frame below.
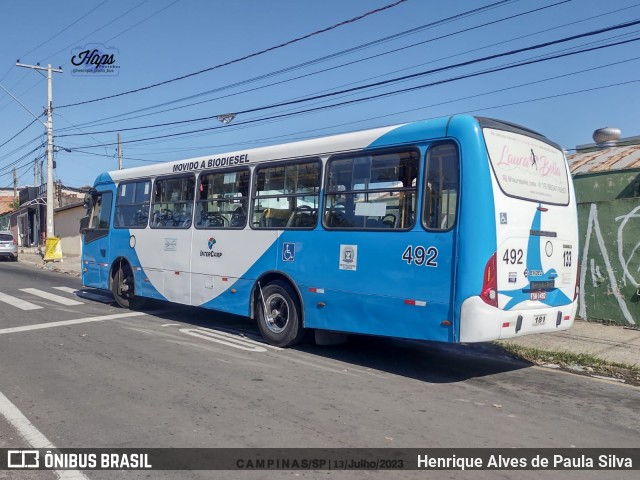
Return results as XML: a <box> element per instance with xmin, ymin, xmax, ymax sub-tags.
<box><xmin>422</xmin><ymin>142</ymin><xmax>460</xmax><ymax>230</ymax></box>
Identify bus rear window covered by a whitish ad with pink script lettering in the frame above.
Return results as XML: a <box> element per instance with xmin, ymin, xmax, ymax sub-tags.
<box><xmin>482</xmin><ymin>128</ymin><xmax>569</xmax><ymax>205</ymax></box>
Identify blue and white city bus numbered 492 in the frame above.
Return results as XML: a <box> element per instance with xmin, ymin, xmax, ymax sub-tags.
<box><xmin>82</xmin><ymin>115</ymin><xmax>578</xmax><ymax>346</ymax></box>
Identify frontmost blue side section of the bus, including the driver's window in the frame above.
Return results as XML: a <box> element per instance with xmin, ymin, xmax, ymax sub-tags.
<box><xmin>82</xmin><ymin>192</ymin><xmax>113</xmax><ymax>289</ymax></box>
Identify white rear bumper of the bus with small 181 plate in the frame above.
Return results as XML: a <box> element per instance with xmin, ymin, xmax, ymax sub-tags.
<box><xmin>460</xmin><ymin>297</ymin><xmax>578</xmax><ymax>342</ymax></box>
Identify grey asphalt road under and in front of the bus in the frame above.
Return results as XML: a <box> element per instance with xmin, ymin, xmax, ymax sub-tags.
<box><xmin>0</xmin><ymin>262</ymin><xmax>640</xmax><ymax>479</ymax></box>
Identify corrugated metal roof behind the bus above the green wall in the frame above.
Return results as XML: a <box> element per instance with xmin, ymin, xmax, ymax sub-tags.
<box><xmin>567</xmin><ymin>145</ymin><xmax>640</xmax><ymax>175</ymax></box>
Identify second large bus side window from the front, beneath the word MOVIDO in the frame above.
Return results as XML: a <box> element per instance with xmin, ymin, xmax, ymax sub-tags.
<box><xmin>151</xmin><ymin>175</ymin><xmax>195</xmax><ymax>228</ymax></box>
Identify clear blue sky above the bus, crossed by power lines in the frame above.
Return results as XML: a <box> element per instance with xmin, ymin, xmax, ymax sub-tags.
<box><xmin>0</xmin><ymin>0</ymin><xmax>640</xmax><ymax>187</ymax></box>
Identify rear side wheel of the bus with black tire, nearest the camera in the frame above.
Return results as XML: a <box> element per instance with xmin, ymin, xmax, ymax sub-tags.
<box><xmin>255</xmin><ymin>280</ymin><xmax>305</xmax><ymax>347</ymax></box>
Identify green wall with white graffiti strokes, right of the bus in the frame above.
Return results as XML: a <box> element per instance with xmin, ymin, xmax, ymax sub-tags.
<box><xmin>576</xmin><ymin>196</ymin><xmax>640</xmax><ymax>327</ymax></box>
